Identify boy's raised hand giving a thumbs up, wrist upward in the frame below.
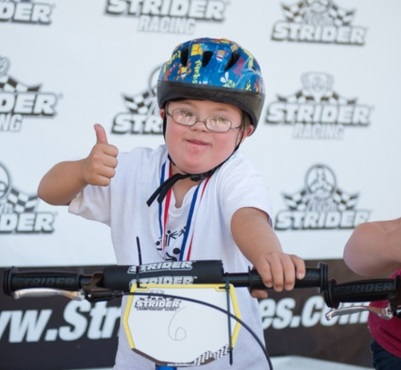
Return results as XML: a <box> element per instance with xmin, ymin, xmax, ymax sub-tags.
<box><xmin>83</xmin><ymin>123</ymin><xmax>118</xmax><ymax>186</ymax></box>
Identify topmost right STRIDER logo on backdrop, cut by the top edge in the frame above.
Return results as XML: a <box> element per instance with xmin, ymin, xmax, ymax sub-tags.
<box><xmin>271</xmin><ymin>0</ymin><xmax>367</xmax><ymax>46</ymax></box>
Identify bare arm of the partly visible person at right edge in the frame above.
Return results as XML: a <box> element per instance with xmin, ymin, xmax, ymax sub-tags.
<box><xmin>344</xmin><ymin>218</ymin><xmax>401</xmax><ymax>276</ymax></box>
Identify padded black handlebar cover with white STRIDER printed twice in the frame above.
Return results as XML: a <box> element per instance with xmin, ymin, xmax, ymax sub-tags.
<box><xmin>102</xmin><ymin>260</ymin><xmax>223</xmax><ymax>292</ymax></box>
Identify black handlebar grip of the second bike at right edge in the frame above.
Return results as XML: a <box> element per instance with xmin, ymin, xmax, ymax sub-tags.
<box><xmin>323</xmin><ymin>279</ymin><xmax>399</xmax><ymax>308</ymax></box>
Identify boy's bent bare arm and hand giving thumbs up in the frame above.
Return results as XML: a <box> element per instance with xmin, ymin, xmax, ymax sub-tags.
<box><xmin>38</xmin><ymin>124</ymin><xmax>118</xmax><ymax>205</ymax></box>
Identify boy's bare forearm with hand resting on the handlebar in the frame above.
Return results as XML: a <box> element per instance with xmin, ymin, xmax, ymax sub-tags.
<box><xmin>231</xmin><ymin>208</ymin><xmax>305</xmax><ymax>298</ymax></box>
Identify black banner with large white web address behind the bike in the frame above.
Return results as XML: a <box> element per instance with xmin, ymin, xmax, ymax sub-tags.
<box><xmin>0</xmin><ymin>260</ymin><xmax>370</xmax><ymax>370</ymax></box>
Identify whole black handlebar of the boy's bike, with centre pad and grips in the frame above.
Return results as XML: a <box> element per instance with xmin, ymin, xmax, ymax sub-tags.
<box><xmin>3</xmin><ymin>260</ymin><xmax>327</xmax><ymax>295</ymax></box>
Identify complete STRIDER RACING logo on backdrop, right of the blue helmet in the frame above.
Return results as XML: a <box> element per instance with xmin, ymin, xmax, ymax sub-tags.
<box><xmin>266</xmin><ymin>72</ymin><xmax>372</xmax><ymax>139</ymax></box>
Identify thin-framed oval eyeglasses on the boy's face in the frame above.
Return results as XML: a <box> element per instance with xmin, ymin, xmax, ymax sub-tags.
<box><xmin>166</xmin><ymin>108</ymin><xmax>241</xmax><ymax>132</ymax></box>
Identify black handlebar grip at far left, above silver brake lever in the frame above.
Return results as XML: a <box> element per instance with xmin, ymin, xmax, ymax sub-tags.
<box><xmin>3</xmin><ymin>267</ymin><xmax>81</xmax><ymax>296</ymax></box>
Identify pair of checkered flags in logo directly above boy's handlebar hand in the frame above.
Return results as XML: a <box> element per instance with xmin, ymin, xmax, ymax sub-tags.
<box><xmin>283</xmin><ymin>188</ymin><xmax>359</xmax><ymax>212</ymax></box>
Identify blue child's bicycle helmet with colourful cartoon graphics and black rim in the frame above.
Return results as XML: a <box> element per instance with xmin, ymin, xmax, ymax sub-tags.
<box><xmin>157</xmin><ymin>38</ymin><xmax>264</xmax><ymax>128</ymax></box>
